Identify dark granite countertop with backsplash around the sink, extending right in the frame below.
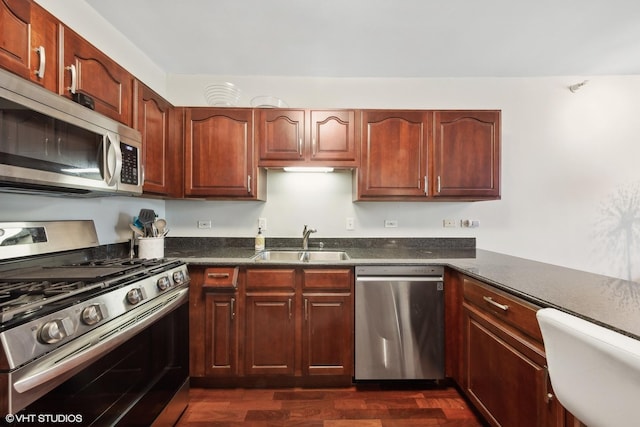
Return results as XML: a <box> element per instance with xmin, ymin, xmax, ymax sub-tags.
<box><xmin>165</xmin><ymin>238</ymin><xmax>640</xmax><ymax>339</ymax></box>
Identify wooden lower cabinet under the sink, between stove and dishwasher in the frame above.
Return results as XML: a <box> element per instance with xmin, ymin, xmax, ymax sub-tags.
<box><xmin>190</xmin><ymin>267</ymin><xmax>354</xmax><ymax>386</ymax></box>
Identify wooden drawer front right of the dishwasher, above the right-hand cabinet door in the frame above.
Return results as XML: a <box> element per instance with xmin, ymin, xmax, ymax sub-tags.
<box><xmin>463</xmin><ymin>277</ymin><xmax>542</xmax><ymax>343</ymax></box>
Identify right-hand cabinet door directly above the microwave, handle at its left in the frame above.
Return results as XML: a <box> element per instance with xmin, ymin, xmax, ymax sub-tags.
<box><xmin>58</xmin><ymin>26</ymin><xmax>133</xmax><ymax>126</ymax></box>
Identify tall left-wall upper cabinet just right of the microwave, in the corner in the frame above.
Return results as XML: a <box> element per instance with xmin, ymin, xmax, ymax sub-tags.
<box><xmin>133</xmin><ymin>80</ymin><xmax>184</xmax><ymax>197</ymax></box>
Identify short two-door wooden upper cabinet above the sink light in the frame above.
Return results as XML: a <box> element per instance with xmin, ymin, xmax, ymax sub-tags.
<box><xmin>256</xmin><ymin>109</ymin><xmax>358</xmax><ymax>167</ymax></box>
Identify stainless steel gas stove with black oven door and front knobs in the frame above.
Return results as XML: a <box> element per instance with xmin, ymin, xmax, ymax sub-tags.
<box><xmin>0</xmin><ymin>221</ymin><xmax>189</xmax><ymax>425</ymax></box>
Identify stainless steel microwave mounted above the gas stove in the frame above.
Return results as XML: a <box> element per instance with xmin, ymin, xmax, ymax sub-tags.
<box><xmin>0</xmin><ymin>70</ymin><xmax>144</xmax><ymax>197</ymax></box>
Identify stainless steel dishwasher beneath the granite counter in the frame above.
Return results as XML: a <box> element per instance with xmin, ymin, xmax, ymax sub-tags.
<box><xmin>355</xmin><ymin>265</ymin><xmax>444</xmax><ymax>380</ymax></box>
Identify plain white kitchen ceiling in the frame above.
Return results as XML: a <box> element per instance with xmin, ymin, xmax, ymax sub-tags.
<box><xmin>85</xmin><ymin>0</ymin><xmax>640</xmax><ymax>77</ymax></box>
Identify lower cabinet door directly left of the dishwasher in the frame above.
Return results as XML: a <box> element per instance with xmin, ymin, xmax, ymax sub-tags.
<box><xmin>302</xmin><ymin>294</ymin><xmax>353</xmax><ymax>376</ymax></box>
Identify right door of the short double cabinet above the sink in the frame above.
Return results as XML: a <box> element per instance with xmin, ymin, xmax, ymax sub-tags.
<box><xmin>309</xmin><ymin>110</ymin><xmax>357</xmax><ymax>166</ymax></box>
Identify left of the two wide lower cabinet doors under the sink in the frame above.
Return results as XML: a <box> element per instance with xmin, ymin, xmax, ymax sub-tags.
<box><xmin>245</xmin><ymin>293</ymin><xmax>296</xmax><ymax>375</ymax></box>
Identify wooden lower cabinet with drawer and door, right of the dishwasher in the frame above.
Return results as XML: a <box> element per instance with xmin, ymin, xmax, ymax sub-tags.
<box><xmin>461</xmin><ymin>277</ymin><xmax>564</xmax><ymax>427</ymax></box>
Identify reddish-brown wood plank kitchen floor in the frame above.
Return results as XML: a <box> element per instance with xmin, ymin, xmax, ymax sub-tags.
<box><xmin>177</xmin><ymin>385</ymin><xmax>482</xmax><ymax>427</ymax></box>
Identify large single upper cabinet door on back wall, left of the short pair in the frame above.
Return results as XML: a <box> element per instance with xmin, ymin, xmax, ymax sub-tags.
<box><xmin>185</xmin><ymin>108</ymin><xmax>256</xmax><ymax>198</ymax></box>
